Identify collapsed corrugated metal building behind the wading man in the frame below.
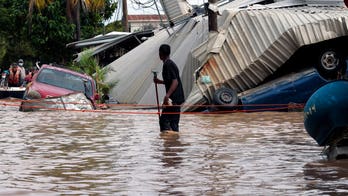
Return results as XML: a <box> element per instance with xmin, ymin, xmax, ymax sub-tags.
<box><xmin>101</xmin><ymin>0</ymin><xmax>348</xmax><ymax>111</ymax></box>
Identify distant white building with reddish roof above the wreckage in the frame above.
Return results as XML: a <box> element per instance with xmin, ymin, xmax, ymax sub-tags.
<box><xmin>128</xmin><ymin>14</ymin><xmax>168</xmax><ymax>32</ymax></box>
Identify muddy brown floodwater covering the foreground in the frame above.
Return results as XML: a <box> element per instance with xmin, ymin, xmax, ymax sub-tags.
<box><xmin>0</xmin><ymin>102</ymin><xmax>348</xmax><ymax>195</ymax></box>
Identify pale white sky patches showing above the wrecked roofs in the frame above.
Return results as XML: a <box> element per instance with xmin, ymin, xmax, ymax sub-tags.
<box><xmin>110</xmin><ymin>0</ymin><xmax>208</xmax><ymax>22</ymax></box>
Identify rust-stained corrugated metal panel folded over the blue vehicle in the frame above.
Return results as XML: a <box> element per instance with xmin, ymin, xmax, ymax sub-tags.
<box><xmin>189</xmin><ymin>7</ymin><xmax>348</xmax><ymax>108</ymax></box>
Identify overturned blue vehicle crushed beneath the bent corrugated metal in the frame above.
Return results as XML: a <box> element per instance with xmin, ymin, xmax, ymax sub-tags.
<box><xmin>213</xmin><ymin>66</ymin><xmax>348</xmax><ymax>112</ymax></box>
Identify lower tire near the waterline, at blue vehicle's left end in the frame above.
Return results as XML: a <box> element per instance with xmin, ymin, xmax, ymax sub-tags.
<box><xmin>213</xmin><ymin>87</ymin><xmax>238</xmax><ymax>109</ymax></box>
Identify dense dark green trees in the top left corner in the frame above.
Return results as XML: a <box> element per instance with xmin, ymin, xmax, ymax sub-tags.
<box><xmin>0</xmin><ymin>0</ymin><xmax>116</xmax><ymax>68</ymax></box>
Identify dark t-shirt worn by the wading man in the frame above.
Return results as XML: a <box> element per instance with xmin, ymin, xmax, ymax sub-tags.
<box><xmin>162</xmin><ymin>59</ymin><xmax>185</xmax><ymax>104</ymax></box>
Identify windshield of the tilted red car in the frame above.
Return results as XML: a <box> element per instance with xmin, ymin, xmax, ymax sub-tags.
<box><xmin>37</xmin><ymin>69</ymin><xmax>92</xmax><ymax>96</ymax></box>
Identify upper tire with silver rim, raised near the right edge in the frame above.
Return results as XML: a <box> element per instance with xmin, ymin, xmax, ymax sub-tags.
<box><xmin>316</xmin><ymin>49</ymin><xmax>346</xmax><ymax>79</ymax></box>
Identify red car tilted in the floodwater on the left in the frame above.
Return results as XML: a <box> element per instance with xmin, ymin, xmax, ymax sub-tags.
<box><xmin>24</xmin><ymin>64</ymin><xmax>99</xmax><ymax>103</ymax></box>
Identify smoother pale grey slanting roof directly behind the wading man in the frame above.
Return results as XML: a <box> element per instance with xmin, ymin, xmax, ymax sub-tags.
<box><xmin>106</xmin><ymin>16</ymin><xmax>208</xmax><ymax>104</ymax></box>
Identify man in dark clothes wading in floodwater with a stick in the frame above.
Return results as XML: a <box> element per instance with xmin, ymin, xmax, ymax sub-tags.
<box><xmin>153</xmin><ymin>44</ymin><xmax>185</xmax><ymax>132</ymax></box>
